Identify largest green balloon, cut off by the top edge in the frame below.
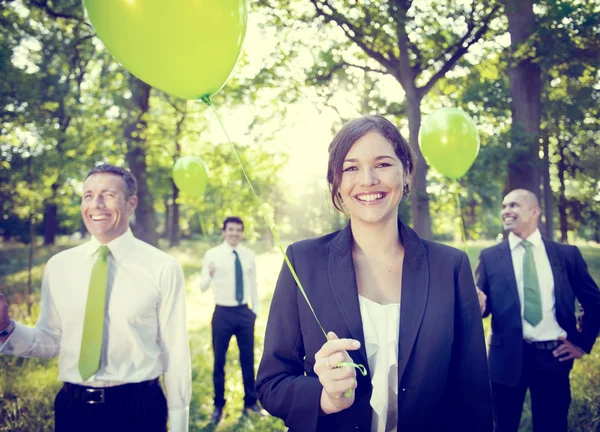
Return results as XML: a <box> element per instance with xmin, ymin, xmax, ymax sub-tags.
<box><xmin>84</xmin><ymin>0</ymin><xmax>248</xmax><ymax>99</ymax></box>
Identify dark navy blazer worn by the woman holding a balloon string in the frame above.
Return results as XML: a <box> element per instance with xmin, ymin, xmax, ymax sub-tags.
<box><xmin>257</xmin><ymin>221</ymin><xmax>492</xmax><ymax>432</ymax></box>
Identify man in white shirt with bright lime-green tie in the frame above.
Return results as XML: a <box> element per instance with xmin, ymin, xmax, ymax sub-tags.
<box><xmin>0</xmin><ymin>165</ymin><xmax>191</xmax><ymax>432</ymax></box>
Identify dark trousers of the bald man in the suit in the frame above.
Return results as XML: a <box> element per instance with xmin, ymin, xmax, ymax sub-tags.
<box><xmin>492</xmin><ymin>343</ymin><xmax>573</xmax><ymax>432</ymax></box>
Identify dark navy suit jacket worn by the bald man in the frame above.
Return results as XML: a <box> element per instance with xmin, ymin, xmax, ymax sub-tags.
<box><xmin>476</xmin><ymin>239</ymin><xmax>600</xmax><ymax>385</ymax></box>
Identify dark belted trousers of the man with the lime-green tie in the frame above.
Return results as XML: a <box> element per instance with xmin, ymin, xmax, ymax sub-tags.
<box><xmin>54</xmin><ymin>380</ymin><xmax>168</xmax><ymax>432</ymax></box>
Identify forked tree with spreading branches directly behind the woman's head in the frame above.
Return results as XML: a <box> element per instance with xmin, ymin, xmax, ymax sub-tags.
<box><xmin>261</xmin><ymin>0</ymin><xmax>500</xmax><ymax>238</ymax></box>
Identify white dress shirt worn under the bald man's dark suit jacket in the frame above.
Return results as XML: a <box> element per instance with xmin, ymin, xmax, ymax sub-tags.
<box><xmin>508</xmin><ymin>229</ymin><xmax>567</xmax><ymax>341</ymax></box>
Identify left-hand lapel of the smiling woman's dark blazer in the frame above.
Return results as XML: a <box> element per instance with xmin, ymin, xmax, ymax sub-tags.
<box><xmin>325</xmin><ymin>224</ymin><xmax>370</xmax><ymax>374</ymax></box>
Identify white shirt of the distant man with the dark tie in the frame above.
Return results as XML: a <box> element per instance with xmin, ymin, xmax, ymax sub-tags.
<box><xmin>200</xmin><ymin>242</ymin><xmax>260</xmax><ymax>315</ymax></box>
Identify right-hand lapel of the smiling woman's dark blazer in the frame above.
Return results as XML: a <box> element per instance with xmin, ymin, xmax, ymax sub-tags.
<box><xmin>398</xmin><ymin>222</ymin><xmax>429</xmax><ymax>385</ymax></box>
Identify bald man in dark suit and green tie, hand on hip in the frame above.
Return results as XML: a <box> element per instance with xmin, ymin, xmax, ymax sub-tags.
<box><xmin>476</xmin><ymin>189</ymin><xmax>600</xmax><ymax>432</ymax></box>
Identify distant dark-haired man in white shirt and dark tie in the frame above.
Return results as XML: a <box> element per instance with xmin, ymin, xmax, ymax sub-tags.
<box><xmin>200</xmin><ymin>216</ymin><xmax>263</xmax><ymax>424</ymax></box>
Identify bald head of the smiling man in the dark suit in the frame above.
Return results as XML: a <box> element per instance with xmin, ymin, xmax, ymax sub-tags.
<box><xmin>501</xmin><ymin>189</ymin><xmax>541</xmax><ymax>239</ymax></box>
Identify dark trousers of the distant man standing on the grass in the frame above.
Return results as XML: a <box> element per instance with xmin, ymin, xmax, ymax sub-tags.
<box><xmin>212</xmin><ymin>305</ymin><xmax>257</xmax><ymax>407</ymax></box>
